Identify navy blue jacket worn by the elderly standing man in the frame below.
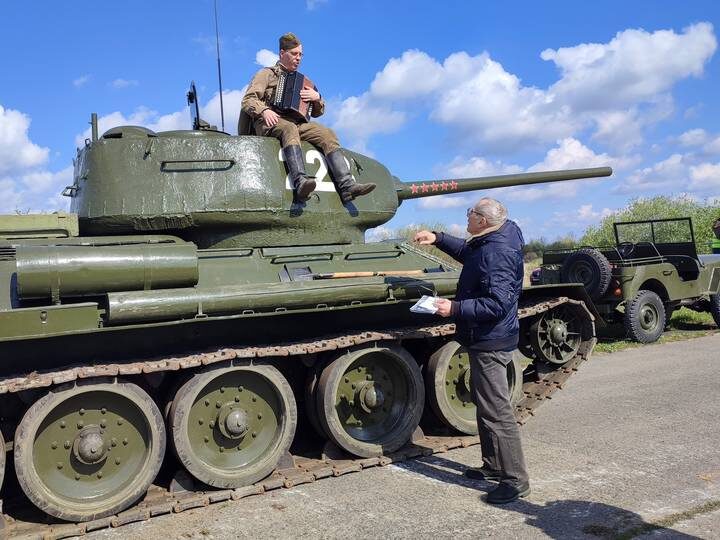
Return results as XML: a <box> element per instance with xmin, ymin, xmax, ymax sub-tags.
<box><xmin>435</xmin><ymin>220</ymin><xmax>525</xmax><ymax>351</ymax></box>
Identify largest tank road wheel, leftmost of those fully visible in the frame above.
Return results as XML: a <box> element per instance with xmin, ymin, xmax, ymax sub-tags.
<box><xmin>14</xmin><ymin>381</ymin><xmax>165</xmax><ymax>521</ymax></box>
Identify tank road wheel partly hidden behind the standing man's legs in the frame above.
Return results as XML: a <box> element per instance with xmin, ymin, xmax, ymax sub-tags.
<box><xmin>425</xmin><ymin>341</ymin><xmax>523</xmax><ymax>435</ymax></box>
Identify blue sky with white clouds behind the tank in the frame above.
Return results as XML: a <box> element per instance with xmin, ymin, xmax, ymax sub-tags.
<box><xmin>0</xmin><ymin>0</ymin><xmax>720</xmax><ymax>240</ymax></box>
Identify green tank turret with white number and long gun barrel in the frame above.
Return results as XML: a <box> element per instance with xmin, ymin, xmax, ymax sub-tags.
<box><xmin>65</xmin><ymin>116</ymin><xmax>612</xmax><ymax>248</ymax></box>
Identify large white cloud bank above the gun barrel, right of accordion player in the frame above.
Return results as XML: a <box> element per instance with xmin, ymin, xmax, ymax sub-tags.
<box><xmin>334</xmin><ymin>23</ymin><xmax>717</xmax><ymax>153</ymax></box>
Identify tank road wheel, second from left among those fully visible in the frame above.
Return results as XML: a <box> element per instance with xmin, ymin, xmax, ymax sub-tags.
<box><xmin>168</xmin><ymin>365</ymin><xmax>297</xmax><ymax>488</ymax></box>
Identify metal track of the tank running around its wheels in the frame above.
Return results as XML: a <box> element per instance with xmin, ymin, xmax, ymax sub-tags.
<box><xmin>0</xmin><ymin>297</ymin><xmax>597</xmax><ymax>540</ymax></box>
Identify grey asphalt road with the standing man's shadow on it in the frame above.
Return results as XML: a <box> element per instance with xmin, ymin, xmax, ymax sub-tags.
<box><xmin>90</xmin><ymin>334</ymin><xmax>720</xmax><ymax>540</ymax></box>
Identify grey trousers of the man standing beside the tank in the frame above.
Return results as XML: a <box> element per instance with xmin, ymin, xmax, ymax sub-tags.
<box><xmin>468</xmin><ymin>349</ymin><xmax>529</xmax><ymax>487</ymax></box>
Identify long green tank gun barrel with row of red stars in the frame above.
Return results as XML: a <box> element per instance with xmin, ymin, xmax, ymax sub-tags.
<box><xmin>396</xmin><ymin>167</ymin><xmax>612</xmax><ymax>201</ymax></box>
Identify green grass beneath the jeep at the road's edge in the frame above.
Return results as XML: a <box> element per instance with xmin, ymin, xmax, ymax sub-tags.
<box><xmin>595</xmin><ymin>308</ymin><xmax>718</xmax><ymax>353</ymax></box>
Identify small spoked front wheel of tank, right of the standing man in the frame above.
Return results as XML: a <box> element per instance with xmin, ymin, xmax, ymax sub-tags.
<box><xmin>529</xmin><ymin>305</ymin><xmax>582</xmax><ymax>365</ymax></box>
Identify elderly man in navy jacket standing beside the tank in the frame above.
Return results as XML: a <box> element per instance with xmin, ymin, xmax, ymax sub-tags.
<box><xmin>415</xmin><ymin>198</ymin><xmax>530</xmax><ymax>504</ymax></box>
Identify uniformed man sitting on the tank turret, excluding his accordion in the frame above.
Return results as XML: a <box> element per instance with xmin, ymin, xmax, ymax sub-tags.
<box><xmin>242</xmin><ymin>33</ymin><xmax>375</xmax><ymax>204</ymax></box>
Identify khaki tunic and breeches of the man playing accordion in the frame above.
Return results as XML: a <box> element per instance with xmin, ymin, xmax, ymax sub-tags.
<box><xmin>242</xmin><ymin>62</ymin><xmax>340</xmax><ymax>154</ymax></box>
